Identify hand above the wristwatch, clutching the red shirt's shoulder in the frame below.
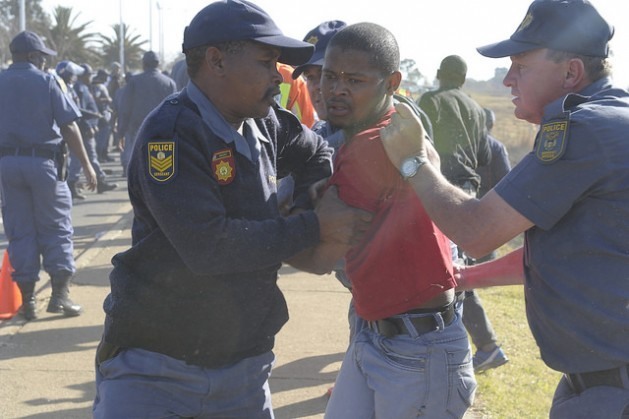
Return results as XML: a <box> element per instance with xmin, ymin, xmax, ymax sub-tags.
<box><xmin>380</xmin><ymin>103</ymin><xmax>427</xmax><ymax>169</ymax></box>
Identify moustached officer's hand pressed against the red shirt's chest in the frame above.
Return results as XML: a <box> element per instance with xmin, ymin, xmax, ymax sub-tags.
<box><xmin>315</xmin><ymin>186</ymin><xmax>373</xmax><ymax>246</ymax></box>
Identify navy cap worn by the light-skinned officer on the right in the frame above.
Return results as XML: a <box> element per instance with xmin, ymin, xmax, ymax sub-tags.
<box><xmin>476</xmin><ymin>0</ymin><xmax>614</xmax><ymax>58</ymax></box>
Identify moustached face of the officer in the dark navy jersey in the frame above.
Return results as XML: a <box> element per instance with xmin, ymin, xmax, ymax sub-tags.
<box><xmin>216</xmin><ymin>42</ymin><xmax>282</xmax><ymax>122</ymax></box>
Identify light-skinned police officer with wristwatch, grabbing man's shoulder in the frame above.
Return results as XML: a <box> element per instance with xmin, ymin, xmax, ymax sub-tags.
<box><xmin>383</xmin><ymin>0</ymin><xmax>629</xmax><ymax>419</ymax></box>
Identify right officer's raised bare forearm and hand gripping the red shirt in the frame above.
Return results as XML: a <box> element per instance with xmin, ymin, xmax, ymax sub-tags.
<box><xmin>381</xmin><ymin>105</ymin><xmax>533</xmax><ymax>257</ymax></box>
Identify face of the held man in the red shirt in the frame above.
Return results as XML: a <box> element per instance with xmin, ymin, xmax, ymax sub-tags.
<box><xmin>321</xmin><ymin>46</ymin><xmax>395</xmax><ymax>133</ymax></box>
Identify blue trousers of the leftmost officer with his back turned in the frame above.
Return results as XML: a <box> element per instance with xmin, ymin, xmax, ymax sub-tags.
<box><xmin>0</xmin><ymin>156</ymin><xmax>75</xmax><ymax>282</ymax></box>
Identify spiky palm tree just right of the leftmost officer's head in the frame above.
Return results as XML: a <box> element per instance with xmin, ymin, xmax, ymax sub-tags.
<box><xmin>50</xmin><ymin>6</ymin><xmax>101</xmax><ymax>66</ymax></box>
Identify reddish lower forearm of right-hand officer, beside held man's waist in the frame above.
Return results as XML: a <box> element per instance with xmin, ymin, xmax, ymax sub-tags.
<box><xmin>457</xmin><ymin>247</ymin><xmax>524</xmax><ymax>291</ymax></box>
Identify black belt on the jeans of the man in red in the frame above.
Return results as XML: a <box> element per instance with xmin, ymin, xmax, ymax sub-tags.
<box><xmin>368</xmin><ymin>303</ymin><xmax>456</xmax><ymax>338</ymax></box>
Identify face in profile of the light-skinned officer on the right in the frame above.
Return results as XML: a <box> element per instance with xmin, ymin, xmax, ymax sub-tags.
<box><xmin>503</xmin><ymin>49</ymin><xmax>568</xmax><ymax>124</ymax></box>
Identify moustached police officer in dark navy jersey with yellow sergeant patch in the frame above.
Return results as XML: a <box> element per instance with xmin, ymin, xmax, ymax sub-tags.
<box><xmin>94</xmin><ymin>0</ymin><xmax>369</xmax><ymax>418</ymax></box>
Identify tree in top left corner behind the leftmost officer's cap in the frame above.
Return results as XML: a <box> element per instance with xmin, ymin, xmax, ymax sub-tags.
<box><xmin>0</xmin><ymin>0</ymin><xmax>50</xmax><ymax>64</ymax></box>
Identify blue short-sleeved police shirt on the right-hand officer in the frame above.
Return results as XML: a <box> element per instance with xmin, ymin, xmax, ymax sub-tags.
<box><xmin>495</xmin><ymin>79</ymin><xmax>629</xmax><ymax>373</ymax></box>
